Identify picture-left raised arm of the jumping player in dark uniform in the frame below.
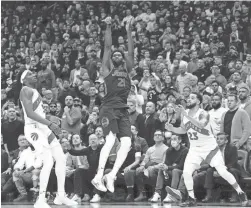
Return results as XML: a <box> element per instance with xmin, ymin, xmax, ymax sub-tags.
<box><xmin>102</xmin><ymin>17</ymin><xmax>112</xmax><ymax>77</ymax></box>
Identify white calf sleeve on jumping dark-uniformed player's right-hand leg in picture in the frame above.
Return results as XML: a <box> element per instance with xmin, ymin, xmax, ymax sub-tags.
<box><xmin>111</xmin><ymin>137</ymin><xmax>132</xmax><ymax>177</ymax></box>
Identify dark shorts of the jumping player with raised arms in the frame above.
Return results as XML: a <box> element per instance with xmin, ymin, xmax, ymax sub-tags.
<box><xmin>100</xmin><ymin>107</ymin><xmax>131</xmax><ymax>138</ymax></box>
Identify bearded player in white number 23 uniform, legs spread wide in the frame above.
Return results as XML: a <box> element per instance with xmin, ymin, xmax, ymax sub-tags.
<box><xmin>166</xmin><ymin>93</ymin><xmax>248</xmax><ymax>206</ymax></box>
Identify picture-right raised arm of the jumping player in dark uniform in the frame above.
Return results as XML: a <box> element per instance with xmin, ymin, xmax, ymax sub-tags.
<box><xmin>125</xmin><ymin>20</ymin><xmax>134</xmax><ymax>72</ymax></box>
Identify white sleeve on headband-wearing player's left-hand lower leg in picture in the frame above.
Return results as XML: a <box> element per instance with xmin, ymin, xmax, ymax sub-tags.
<box><xmin>39</xmin><ymin>148</ymin><xmax>53</xmax><ymax>199</ymax></box>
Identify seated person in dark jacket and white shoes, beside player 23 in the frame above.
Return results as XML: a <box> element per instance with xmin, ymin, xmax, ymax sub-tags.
<box><xmin>151</xmin><ymin>134</ymin><xmax>188</xmax><ymax>202</ymax></box>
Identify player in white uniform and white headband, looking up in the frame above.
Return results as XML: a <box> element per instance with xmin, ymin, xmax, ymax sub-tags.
<box><xmin>20</xmin><ymin>70</ymin><xmax>77</xmax><ymax>208</ymax></box>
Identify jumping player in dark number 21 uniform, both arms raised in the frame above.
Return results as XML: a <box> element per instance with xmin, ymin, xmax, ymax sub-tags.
<box><xmin>92</xmin><ymin>17</ymin><xmax>134</xmax><ymax>192</ymax></box>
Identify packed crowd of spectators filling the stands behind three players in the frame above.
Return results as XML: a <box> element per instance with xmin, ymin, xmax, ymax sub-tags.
<box><xmin>1</xmin><ymin>1</ymin><xmax>251</xmax><ymax>205</ymax></box>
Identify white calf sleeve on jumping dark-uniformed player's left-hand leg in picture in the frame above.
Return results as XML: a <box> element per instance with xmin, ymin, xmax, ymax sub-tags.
<box><xmin>97</xmin><ymin>132</ymin><xmax>116</xmax><ymax>176</ymax></box>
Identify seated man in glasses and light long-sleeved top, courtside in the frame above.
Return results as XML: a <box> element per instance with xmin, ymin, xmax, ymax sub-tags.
<box><xmin>134</xmin><ymin>130</ymin><xmax>168</xmax><ymax>201</ymax></box>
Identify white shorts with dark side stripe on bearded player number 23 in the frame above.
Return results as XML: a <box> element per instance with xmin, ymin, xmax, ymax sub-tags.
<box><xmin>184</xmin><ymin>146</ymin><xmax>225</xmax><ymax>169</ymax></box>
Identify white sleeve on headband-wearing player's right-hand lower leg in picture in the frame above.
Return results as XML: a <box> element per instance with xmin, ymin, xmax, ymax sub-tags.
<box><xmin>51</xmin><ymin>145</ymin><xmax>66</xmax><ymax>197</ymax></box>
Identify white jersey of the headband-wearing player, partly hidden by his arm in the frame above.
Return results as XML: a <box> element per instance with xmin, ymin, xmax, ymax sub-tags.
<box><xmin>21</xmin><ymin>88</ymin><xmax>45</xmax><ymax>126</ymax></box>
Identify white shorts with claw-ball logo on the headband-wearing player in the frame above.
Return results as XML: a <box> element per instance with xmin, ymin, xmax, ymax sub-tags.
<box><xmin>24</xmin><ymin>124</ymin><xmax>60</xmax><ymax>154</ymax></box>
